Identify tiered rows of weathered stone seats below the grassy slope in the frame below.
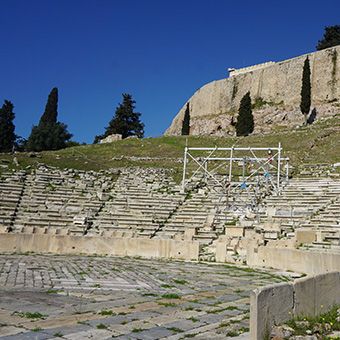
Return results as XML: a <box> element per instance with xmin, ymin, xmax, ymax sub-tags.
<box><xmin>0</xmin><ymin>167</ymin><xmax>340</xmax><ymax>250</ymax></box>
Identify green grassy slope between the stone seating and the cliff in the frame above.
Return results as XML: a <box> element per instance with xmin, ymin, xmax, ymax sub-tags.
<box><xmin>0</xmin><ymin>115</ymin><xmax>340</xmax><ymax>177</ymax></box>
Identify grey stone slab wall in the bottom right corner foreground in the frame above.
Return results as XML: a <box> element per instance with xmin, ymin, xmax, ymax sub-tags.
<box><xmin>250</xmin><ymin>272</ymin><xmax>340</xmax><ymax>340</ymax></box>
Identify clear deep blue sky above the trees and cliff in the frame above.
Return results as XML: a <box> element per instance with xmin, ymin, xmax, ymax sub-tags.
<box><xmin>0</xmin><ymin>0</ymin><xmax>340</xmax><ymax>143</ymax></box>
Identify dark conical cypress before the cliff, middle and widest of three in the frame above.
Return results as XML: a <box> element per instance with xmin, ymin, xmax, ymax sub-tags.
<box><xmin>235</xmin><ymin>92</ymin><xmax>254</xmax><ymax>136</ymax></box>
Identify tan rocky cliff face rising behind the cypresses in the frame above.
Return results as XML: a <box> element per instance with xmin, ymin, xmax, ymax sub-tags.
<box><xmin>165</xmin><ymin>46</ymin><xmax>340</xmax><ymax>136</ymax></box>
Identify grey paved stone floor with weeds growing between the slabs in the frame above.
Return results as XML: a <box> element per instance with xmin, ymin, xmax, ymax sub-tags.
<box><xmin>0</xmin><ymin>255</ymin><xmax>282</xmax><ymax>340</ymax></box>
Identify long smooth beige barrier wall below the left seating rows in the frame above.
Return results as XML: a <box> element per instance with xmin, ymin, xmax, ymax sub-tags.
<box><xmin>0</xmin><ymin>234</ymin><xmax>199</xmax><ymax>260</ymax></box>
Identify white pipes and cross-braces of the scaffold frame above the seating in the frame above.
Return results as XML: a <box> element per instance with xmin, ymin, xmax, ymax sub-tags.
<box><xmin>182</xmin><ymin>143</ymin><xmax>289</xmax><ymax>195</ymax></box>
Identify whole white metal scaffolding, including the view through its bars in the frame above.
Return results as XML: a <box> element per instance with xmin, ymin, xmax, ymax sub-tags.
<box><xmin>182</xmin><ymin>143</ymin><xmax>289</xmax><ymax>212</ymax></box>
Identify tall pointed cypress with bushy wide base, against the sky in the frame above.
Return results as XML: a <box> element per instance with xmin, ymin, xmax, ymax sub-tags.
<box><xmin>27</xmin><ymin>87</ymin><xmax>72</xmax><ymax>151</ymax></box>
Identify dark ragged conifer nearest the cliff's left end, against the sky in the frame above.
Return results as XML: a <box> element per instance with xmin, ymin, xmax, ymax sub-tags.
<box><xmin>94</xmin><ymin>93</ymin><xmax>144</xmax><ymax>143</ymax></box>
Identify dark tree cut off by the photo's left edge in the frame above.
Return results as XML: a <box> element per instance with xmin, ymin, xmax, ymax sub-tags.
<box><xmin>0</xmin><ymin>100</ymin><xmax>16</xmax><ymax>152</ymax></box>
